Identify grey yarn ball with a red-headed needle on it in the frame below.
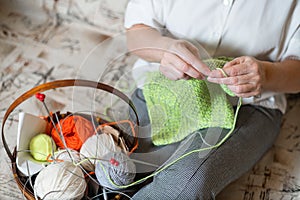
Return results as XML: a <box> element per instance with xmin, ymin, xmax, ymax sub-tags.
<box><xmin>95</xmin><ymin>152</ymin><xmax>136</xmax><ymax>190</ymax></box>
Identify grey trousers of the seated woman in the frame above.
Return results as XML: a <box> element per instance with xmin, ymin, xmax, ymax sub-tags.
<box><xmin>128</xmin><ymin>89</ymin><xmax>282</xmax><ymax>200</ymax></box>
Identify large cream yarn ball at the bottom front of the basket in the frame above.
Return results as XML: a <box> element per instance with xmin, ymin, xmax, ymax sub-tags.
<box><xmin>34</xmin><ymin>161</ymin><xmax>87</xmax><ymax>200</ymax></box>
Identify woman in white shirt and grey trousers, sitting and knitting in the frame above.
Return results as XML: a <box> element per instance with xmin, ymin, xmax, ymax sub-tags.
<box><xmin>125</xmin><ymin>0</ymin><xmax>300</xmax><ymax>200</ymax></box>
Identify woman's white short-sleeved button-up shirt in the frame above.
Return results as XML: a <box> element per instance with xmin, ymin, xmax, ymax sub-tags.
<box><xmin>125</xmin><ymin>0</ymin><xmax>300</xmax><ymax>112</ymax></box>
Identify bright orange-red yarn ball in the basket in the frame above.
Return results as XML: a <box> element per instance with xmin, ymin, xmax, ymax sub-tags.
<box><xmin>51</xmin><ymin>115</ymin><xmax>95</xmax><ymax>151</ymax></box>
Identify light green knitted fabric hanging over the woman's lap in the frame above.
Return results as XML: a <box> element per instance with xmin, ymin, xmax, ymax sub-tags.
<box><xmin>143</xmin><ymin>57</ymin><xmax>234</xmax><ymax>145</ymax></box>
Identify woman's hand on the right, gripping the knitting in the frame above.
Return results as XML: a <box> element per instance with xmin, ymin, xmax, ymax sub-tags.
<box><xmin>207</xmin><ymin>56</ymin><xmax>266</xmax><ymax>97</ymax></box>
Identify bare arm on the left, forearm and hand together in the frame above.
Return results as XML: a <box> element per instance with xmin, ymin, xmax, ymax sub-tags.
<box><xmin>126</xmin><ymin>24</ymin><xmax>210</xmax><ymax>80</ymax></box>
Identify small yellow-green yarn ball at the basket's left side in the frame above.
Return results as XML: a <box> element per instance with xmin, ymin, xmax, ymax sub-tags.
<box><xmin>29</xmin><ymin>133</ymin><xmax>56</xmax><ymax>161</ymax></box>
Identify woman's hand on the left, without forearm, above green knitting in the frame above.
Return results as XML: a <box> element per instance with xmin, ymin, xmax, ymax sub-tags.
<box><xmin>160</xmin><ymin>40</ymin><xmax>210</xmax><ymax>80</ymax></box>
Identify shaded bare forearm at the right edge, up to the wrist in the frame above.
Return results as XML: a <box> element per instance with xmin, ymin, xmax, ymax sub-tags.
<box><xmin>262</xmin><ymin>60</ymin><xmax>300</xmax><ymax>93</ymax></box>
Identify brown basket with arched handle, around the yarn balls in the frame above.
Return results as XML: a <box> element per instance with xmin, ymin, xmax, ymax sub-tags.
<box><xmin>2</xmin><ymin>79</ymin><xmax>139</xmax><ymax>200</ymax></box>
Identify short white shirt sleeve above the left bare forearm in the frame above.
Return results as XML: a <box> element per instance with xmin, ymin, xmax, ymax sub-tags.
<box><xmin>124</xmin><ymin>0</ymin><xmax>164</xmax><ymax>30</ymax></box>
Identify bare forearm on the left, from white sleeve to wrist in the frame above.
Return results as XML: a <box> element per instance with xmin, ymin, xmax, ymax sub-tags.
<box><xmin>127</xmin><ymin>24</ymin><xmax>173</xmax><ymax>62</ymax></box>
